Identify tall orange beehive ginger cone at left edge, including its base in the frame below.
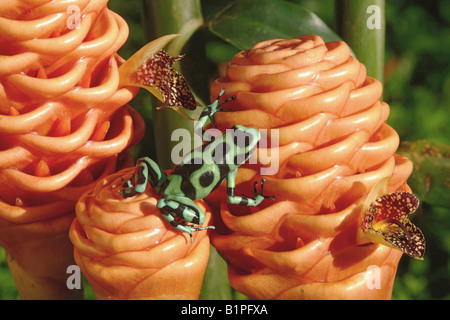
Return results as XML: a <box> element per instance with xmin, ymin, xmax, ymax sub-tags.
<box><xmin>0</xmin><ymin>0</ymin><xmax>144</xmax><ymax>299</ymax></box>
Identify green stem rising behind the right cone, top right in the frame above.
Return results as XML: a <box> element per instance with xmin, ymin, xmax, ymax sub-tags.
<box><xmin>336</xmin><ymin>0</ymin><xmax>386</xmax><ymax>82</ymax></box>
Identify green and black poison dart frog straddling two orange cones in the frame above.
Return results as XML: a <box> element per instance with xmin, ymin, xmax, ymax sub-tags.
<box><xmin>120</xmin><ymin>90</ymin><xmax>274</xmax><ymax>242</ymax></box>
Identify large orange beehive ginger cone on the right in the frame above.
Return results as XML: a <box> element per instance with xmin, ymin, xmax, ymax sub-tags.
<box><xmin>207</xmin><ymin>35</ymin><xmax>424</xmax><ymax>299</ymax></box>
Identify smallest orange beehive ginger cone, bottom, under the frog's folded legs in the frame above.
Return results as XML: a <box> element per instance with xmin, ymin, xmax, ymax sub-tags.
<box><xmin>70</xmin><ymin>167</ymin><xmax>211</xmax><ymax>299</ymax></box>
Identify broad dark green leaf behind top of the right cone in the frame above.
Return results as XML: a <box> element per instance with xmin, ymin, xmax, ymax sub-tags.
<box><xmin>209</xmin><ymin>0</ymin><xmax>340</xmax><ymax>50</ymax></box>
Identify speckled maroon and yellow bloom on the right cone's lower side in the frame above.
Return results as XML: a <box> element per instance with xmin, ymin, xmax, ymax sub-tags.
<box><xmin>361</xmin><ymin>180</ymin><xmax>425</xmax><ymax>260</ymax></box>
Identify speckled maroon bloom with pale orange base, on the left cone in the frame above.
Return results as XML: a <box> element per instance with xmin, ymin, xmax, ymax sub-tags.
<box><xmin>119</xmin><ymin>34</ymin><xmax>197</xmax><ymax>111</ymax></box>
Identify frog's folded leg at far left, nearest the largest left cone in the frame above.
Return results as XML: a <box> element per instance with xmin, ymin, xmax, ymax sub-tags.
<box><xmin>120</xmin><ymin>157</ymin><xmax>167</xmax><ymax>198</ymax></box>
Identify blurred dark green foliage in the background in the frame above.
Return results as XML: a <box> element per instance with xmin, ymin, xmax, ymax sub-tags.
<box><xmin>0</xmin><ymin>0</ymin><xmax>450</xmax><ymax>300</ymax></box>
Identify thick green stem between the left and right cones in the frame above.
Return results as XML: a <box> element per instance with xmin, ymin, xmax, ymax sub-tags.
<box><xmin>142</xmin><ymin>0</ymin><xmax>232</xmax><ymax>300</ymax></box>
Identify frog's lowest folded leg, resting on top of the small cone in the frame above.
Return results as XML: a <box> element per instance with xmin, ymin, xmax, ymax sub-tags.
<box><xmin>156</xmin><ymin>196</ymin><xmax>214</xmax><ymax>243</ymax></box>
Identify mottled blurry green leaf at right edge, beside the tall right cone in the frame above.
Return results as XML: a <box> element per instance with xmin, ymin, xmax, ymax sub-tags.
<box><xmin>398</xmin><ymin>140</ymin><xmax>450</xmax><ymax>208</ymax></box>
